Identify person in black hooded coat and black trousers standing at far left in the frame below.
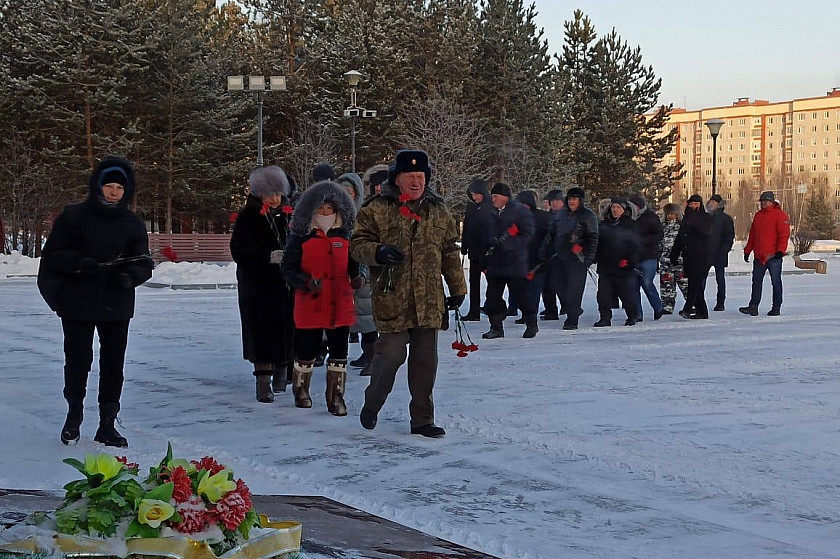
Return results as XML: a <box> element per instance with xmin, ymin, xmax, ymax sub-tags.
<box><xmin>38</xmin><ymin>157</ymin><xmax>154</xmax><ymax>447</ymax></box>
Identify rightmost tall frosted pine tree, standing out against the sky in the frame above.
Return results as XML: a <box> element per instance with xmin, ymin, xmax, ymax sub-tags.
<box><xmin>558</xmin><ymin>10</ymin><xmax>681</xmax><ymax>202</ymax></box>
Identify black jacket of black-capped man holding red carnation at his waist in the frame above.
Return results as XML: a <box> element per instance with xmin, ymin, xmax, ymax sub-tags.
<box><xmin>540</xmin><ymin>204</ymin><xmax>599</xmax><ymax>267</ymax></box>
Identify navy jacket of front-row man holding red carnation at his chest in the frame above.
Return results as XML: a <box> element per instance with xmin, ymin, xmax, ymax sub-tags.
<box><xmin>485</xmin><ymin>200</ymin><xmax>536</xmax><ymax>278</ymax></box>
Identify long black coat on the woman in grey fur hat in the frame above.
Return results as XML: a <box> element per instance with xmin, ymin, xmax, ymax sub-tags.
<box><xmin>230</xmin><ymin>193</ymin><xmax>295</xmax><ymax>364</ymax></box>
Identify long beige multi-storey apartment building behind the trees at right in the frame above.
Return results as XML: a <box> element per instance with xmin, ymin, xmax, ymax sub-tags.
<box><xmin>666</xmin><ymin>88</ymin><xmax>840</xmax><ymax>216</ymax></box>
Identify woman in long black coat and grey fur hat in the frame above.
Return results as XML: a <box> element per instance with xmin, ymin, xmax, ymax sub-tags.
<box><xmin>230</xmin><ymin>166</ymin><xmax>295</xmax><ymax>403</ymax></box>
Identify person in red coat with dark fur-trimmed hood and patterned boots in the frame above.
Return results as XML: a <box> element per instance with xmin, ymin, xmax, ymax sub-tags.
<box><xmin>280</xmin><ymin>181</ymin><xmax>359</xmax><ymax>415</ymax></box>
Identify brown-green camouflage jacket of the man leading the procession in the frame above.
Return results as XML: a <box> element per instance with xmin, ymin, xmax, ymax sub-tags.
<box><xmin>350</xmin><ymin>184</ymin><xmax>467</xmax><ymax>334</ymax></box>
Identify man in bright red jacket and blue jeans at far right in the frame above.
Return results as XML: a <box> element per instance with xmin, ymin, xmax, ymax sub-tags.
<box><xmin>738</xmin><ymin>190</ymin><xmax>790</xmax><ymax>316</ymax></box>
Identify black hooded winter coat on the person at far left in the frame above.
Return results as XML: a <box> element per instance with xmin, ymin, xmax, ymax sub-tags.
<box><xmin>38</xmin><ymin>157</ymin><xmax>154</xmax><ymax>322</ymax></box>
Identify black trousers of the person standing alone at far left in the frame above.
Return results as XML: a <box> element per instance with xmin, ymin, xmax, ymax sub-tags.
<box><xmin>61</xmin><ymin>318</ymin><xmax>129</xmax><ymax>404</ymax></box>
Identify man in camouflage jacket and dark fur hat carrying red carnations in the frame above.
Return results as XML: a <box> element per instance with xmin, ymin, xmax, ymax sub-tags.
<box><xmin>350</xmin><ymin>150</ymin><xmax>467</xmax><ymax>437</ymax></box>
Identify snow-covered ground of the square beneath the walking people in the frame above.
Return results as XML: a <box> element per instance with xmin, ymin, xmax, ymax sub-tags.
<box><xmin>0</xmin><ymin>251</ymin><xmax>840</xmax><ymax>559</ymax></box>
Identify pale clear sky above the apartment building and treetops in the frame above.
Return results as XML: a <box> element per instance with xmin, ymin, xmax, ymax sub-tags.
<box><xmin>526</xmin><ymin>0</ymin><xmax>840</xmax><ymax>110</ymax></box>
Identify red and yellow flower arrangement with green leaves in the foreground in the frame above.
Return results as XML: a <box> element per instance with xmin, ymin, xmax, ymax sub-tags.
<box><xmin>55</xmin><ymin>445</ymin><xmax>261</xmax><ymax>556</ymax></box>
